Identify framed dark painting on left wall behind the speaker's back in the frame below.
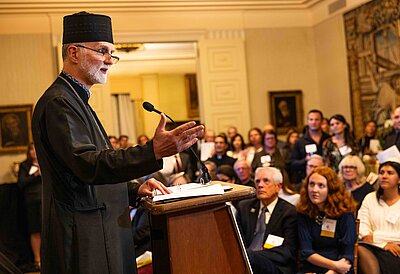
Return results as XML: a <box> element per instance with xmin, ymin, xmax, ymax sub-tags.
<box><xmin>0</xmin><ymin>105</ymin><xmax>33</xmax><ymax>152</ymax></box>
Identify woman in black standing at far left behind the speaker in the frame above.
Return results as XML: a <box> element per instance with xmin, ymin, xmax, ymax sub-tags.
<box><xmin>18</xmin><ymin>143</ymin><xmax>42</xmax><ymax>271</ymax></box>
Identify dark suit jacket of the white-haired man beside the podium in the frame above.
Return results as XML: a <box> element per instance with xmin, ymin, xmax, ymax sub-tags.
<box><xmin>237</xmin><ymin>198</ymin><xmax>297</xmax><ymax>273</ymax></box>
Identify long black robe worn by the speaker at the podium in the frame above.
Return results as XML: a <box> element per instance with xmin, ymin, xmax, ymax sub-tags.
<box><xmin>32</xmin><ymin>74</ymin><xmax>162</xmax><ymax>274</ymax></box>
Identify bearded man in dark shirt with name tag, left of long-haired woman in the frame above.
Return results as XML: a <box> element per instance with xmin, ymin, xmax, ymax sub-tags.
<box><xmin>289</xmin><ymin>109</ymin><xmax>330</xmax><ymax>183</ymax></box>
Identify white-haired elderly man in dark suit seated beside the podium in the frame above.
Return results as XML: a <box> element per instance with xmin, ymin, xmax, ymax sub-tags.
<box><xmin>237</xmin><ymin>167</ymin><xmax>297</xmax><ymax>274</ymax></box>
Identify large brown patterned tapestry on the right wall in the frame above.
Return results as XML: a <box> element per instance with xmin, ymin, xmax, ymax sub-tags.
<box><xmin>344</xmin><ymin>0</ymin><xmax>400</xmax><ymax>136</ymax></box>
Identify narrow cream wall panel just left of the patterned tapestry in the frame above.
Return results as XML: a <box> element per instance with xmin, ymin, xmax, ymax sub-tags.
<box><xmin>313</xmin><ymin>15</ymin><xmax>352</xmax><ymax>123</ymax></box>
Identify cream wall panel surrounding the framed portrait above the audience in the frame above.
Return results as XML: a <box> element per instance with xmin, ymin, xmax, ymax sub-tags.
<box><xmin>246</xmin><ymin>28</ymin><xmax>320</xmax><ymax>130</ymax></box>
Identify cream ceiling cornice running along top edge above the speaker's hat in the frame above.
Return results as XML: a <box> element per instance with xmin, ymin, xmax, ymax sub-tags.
<box><xmin>0</xmin><ymin>0</ymin><xmax>324</xmax><ymax>14</ymax></box>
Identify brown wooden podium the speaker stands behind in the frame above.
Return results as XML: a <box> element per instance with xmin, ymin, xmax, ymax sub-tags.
<box><xmin>143</xmin><ymin>181</ymin><xmax>255</xmax><ymax>274</ymax></box>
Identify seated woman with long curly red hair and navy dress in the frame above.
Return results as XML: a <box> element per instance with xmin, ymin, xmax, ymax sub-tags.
<box><xmin>297</xmin><ymin>167</ymin><xmax>357</xmax><ymax>274</ymax></box>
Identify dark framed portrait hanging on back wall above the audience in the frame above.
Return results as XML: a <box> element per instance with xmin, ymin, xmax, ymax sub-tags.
<box><xmin>268</xmin><ymin>90</ymin><xmax>303</xmax><ymax>135</ymax></box>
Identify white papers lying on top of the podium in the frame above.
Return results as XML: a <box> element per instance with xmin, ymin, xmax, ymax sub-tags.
<box><xmin>153</xmin><ymin>183</ymin><xmax>224</xmax><ymax>203</ymax></box>
